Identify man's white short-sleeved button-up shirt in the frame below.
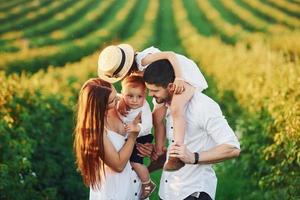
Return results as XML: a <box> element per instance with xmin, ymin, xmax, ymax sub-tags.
<box><xmin>159</xmin><ymin>90</ymin><xmax>240</xmax><ymax>200</ymax></box>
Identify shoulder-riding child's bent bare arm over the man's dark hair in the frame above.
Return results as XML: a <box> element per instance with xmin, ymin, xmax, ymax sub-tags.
<box><xmin>142</xmin><ymin>51</ymin><xmax>182</xmax><ymax>78</ymax></box>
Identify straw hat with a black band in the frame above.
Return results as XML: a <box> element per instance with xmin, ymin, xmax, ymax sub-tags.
<box><xmin>98</xmin><ymin>44</ymin><xmax>134</xmax><ymax>83</ymax></box>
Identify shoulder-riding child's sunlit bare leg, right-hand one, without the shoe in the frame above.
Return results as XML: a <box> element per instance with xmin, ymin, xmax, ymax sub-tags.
<box><xmin>171</xmin><ymin>83</ymin><xmax>195</xmax><ymax>144</ymax></box>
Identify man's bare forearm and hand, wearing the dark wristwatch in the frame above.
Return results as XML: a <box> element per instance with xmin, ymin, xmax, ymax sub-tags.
<box><xmin>170</xmin><ymin>144</ymin><xmax>240</xmax><ymax>164</ymax></box>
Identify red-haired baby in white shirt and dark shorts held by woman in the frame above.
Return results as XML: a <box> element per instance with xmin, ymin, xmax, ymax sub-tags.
<box><xmin>118</xmin><ymin>75</ymin><xmax>156</xmax><ymax>199</ymax></box>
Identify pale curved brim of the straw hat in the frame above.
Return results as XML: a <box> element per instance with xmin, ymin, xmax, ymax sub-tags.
<box><xmin>98</xmin><ymin>44</ymin><xmax>134</xmax><ymax>83</ymax></box>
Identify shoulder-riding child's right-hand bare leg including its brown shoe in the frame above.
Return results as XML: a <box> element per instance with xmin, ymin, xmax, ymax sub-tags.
<box><xmin>164</xmin><ymin>83</ymin><xmax>195</xmax><ymax>171</ymax></box>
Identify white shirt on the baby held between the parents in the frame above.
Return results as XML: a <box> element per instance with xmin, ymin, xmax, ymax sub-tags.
<box><xmin>119</xmin><ymin>100</ymin><xmax>153</xmax><ymax>137</ymax></box>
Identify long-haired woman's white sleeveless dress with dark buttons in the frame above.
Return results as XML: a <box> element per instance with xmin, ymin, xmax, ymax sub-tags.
<box><xmin>90</xmin><ymin>130</ymin><xmax>145</xmax><ymax>200</ymax></box>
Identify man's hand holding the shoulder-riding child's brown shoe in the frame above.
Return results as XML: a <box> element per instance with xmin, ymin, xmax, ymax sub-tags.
<box><xmin>170</xmin><ymin>144</ymin><xmax>195</xmax><ymax>164</ymax></box>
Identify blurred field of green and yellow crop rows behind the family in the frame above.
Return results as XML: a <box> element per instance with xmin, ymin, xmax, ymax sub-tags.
<box><xmin>0</xmin><ymin>0</ymin><xmax>300</xmax><ymax>200</ymax></box>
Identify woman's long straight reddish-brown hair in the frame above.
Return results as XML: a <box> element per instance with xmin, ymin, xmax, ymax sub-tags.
<box><xmin>73</xmin><ymin>78</ymin><xmax>112</xmax><ymax>188</ymax></box>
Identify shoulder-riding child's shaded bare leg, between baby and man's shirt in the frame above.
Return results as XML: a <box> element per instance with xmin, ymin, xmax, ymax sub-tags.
<box><xmin>152</xmin><ymin>105</ymin><xmax>167</xmax><ymax>156</ymax></box>
